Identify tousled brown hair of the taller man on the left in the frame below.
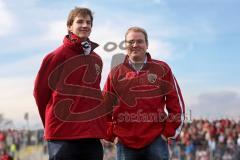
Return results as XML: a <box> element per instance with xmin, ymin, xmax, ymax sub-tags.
<box><xmin>67</xmin><ymin>7</ymin><xmax>93</xmax><ymax>27</ymax></box>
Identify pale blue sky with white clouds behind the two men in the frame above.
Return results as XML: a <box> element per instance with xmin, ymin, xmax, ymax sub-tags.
<box><xmin>0</xmin><ymin>0</ymin><xmax>240</xmax><ymax>128</ymax></box>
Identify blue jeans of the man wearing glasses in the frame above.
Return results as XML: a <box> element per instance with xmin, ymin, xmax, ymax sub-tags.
<box><xmin>117</xmin><ymin>136</ymin><xmax>169</xmax><ymax>160</ymax></box>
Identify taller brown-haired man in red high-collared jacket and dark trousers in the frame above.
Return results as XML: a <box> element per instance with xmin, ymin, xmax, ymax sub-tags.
<box><xmin>34</xmin><ymin>7</ymin><xmax>106</xmax><ymax>160</ymax></box>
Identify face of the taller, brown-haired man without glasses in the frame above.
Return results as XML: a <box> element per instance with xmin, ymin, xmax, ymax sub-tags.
<box><xmin>68</xmin><ymin>15</ymin><xmax>92</xmax><ymax>40</ymax></box>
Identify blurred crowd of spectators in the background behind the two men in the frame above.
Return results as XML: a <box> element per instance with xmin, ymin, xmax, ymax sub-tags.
<box><xmin>0</xmin><ymin>119</ymin><xmax>240</xmax><ymax>160</ymax></box>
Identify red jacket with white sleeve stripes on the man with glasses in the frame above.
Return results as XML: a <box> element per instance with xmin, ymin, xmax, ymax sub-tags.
<box><xmin>104</xmin><ymin>53</ymin><xmax>185</xmax><ymax>148</ymax></box>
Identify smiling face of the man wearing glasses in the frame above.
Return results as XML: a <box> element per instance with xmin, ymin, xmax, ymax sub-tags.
<box><xmin>126</xmin><ymin>31</ymin><xmax>148</xmax><ymax>62</ymax></box>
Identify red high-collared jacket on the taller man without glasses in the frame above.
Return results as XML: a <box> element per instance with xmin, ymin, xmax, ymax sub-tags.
<box><xmin>34</xmin><ymin>34</ymin><xmax>106</xmax><ymax>140</ymax></box>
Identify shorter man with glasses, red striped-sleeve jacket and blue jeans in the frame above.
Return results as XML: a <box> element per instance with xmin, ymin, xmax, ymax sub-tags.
<box><xmin>104</xmin><ymin>27</ymin><xmax>185</xmax><ymax>160</ymax></box>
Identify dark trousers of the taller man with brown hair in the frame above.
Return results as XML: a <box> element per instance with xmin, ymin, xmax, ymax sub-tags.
<box><xmin>48</xmin><ymin>139</ymin><xmax>103</xmax><ymax>160</ymax></box>
